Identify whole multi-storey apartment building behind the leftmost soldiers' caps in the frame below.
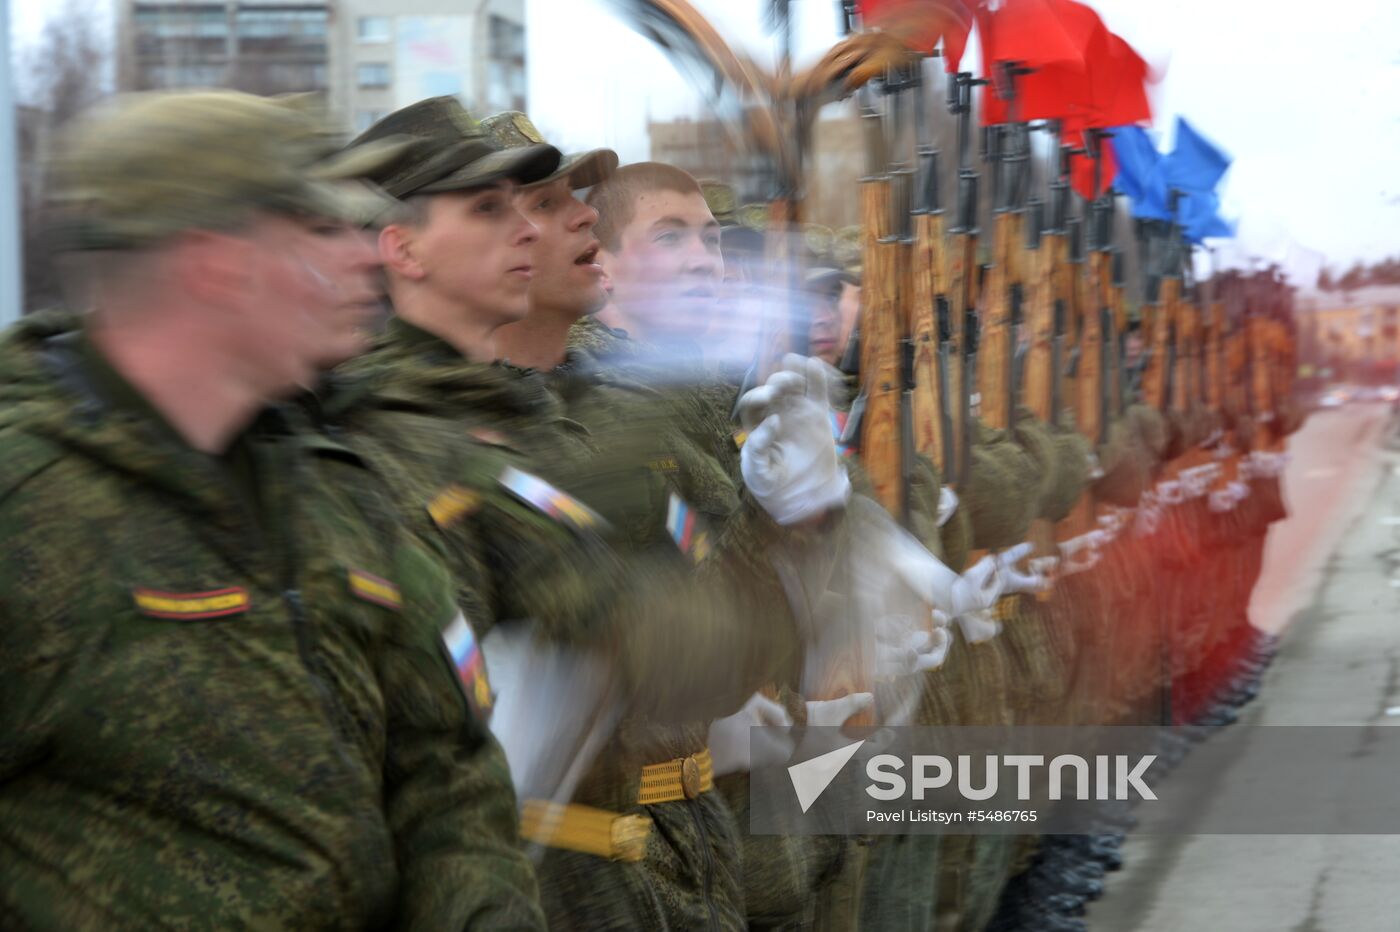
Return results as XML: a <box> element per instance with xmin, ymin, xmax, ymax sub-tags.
<box><xmin>118</xmin><ymin>0</ymin><xmax>528</xmax><ymax>132</ymax></box>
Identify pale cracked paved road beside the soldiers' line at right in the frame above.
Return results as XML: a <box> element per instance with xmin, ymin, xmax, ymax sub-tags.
<box><xmin>1089</xmin><ymin>406</ymin><xmax>1400</xmax><ymax>932</ymax></box>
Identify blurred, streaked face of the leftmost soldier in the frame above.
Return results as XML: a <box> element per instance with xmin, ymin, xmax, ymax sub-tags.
<box><xmin>241</xmin><ymin>209</ymin><xmax>379</xmax><ymax>388</ymax></box>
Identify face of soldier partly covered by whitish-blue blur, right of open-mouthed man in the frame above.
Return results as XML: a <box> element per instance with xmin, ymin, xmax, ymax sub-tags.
<box><xmin>601</xmin><ymin>190</ymin><xmax>724</xmax><ymax>340</ymax></box>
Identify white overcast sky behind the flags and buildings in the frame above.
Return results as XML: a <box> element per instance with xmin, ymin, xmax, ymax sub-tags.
<box><xmin>10</xmin><ymin>0</ymin><xmax>1400</xmax><ymax>275</ymax></box>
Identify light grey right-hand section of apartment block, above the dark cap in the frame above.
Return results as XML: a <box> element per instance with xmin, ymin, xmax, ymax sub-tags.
<box><xmin>329</xmin><ymin>0</ymin><xmax>529</xmax><ymax>132</ymax></box>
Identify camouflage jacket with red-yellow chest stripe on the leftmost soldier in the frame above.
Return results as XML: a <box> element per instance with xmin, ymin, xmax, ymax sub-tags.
<box><xmin>0</xmin><ymin>315</ymin><xmax>543</xmax><ymax>929</ymax></box>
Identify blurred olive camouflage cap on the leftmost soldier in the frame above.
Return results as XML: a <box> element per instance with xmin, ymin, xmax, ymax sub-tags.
<box><xmin>53</xmin><ymin>91</ymin><xmax>405</xmax><ymax>249</ymax></box>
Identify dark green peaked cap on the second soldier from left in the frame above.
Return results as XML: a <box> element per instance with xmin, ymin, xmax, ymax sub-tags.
<box><xmin>349</xmin><ymin>97</ymin><xmax>559</xmax><ymax>199</ymax></box>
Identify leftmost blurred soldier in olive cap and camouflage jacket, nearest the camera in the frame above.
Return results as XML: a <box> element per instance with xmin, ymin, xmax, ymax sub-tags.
<box><xmin>0</xmin><ymin>92</ymin><xmax>542</xmax><ymax>929</ymax></box>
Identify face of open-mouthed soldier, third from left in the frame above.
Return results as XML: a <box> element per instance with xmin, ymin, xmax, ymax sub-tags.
<box><xmin>515</xmin><ymin>178</ymin><xmax>608</xmax><ymax>318</ymax></box>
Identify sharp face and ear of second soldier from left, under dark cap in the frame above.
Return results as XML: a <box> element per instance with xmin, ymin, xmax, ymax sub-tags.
<box><xmin>379</xmin><ymin>182</ymin><xmax>538</xmax><ymax>326</ymax></box>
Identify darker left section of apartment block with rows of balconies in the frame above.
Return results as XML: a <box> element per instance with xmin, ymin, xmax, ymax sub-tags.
<box><xmin>118</xmin><ymin>0</ymin><xmax>332</xmax><ymax>94</ymax></box>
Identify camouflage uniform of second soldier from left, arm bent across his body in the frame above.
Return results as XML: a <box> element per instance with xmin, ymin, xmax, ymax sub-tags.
<box><xmin>336</xmin><ymin>320</ymin><xmax>797</xmax><ymax>929</ymax></box>
